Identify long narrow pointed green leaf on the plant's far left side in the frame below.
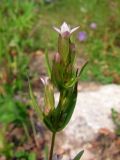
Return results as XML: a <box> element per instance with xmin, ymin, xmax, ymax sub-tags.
<box><xmin>28</xmin><ymin>79</ymin><xmax>43</xmax><ymax>119</ymax></box>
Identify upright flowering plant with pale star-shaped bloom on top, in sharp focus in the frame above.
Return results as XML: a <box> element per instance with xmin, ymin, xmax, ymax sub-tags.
<box><xmin>30</xmin><ymin>22</ymin><xmax>86</xmax><ymax>160</ymax></box>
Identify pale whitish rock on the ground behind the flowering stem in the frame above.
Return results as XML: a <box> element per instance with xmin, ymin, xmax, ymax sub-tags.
<box><xmin>56</xmin><ymin>84</ymin><xmax>120</xmax><ymax>160</ymax></box>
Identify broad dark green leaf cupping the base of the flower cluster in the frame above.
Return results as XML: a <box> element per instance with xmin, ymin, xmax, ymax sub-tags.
<box><xmin>43</xmin><ymin>84</ymin><xmax>77</xmax><ymax>132</ymax></box>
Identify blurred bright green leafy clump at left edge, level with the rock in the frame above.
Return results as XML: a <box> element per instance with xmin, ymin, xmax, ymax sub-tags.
<box><xmin>0</xmin><ymin>96</ymin><xmax>28</xmax><ymax>125</ymax></box>
